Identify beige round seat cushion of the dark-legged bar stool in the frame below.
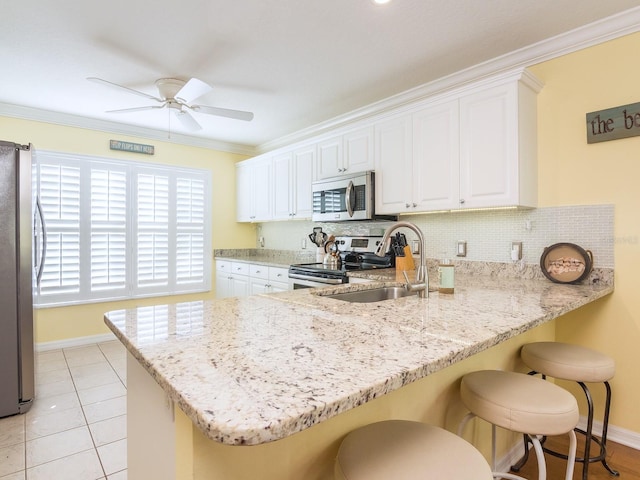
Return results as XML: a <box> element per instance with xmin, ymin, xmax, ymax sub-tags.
<box><xmin>520</xmin><ymin>342</ymin><xmax>616</xmax><ymax>383</ymax></box>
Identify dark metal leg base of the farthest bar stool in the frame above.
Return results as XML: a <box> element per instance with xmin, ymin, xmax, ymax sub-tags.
<box><xmin>511</xmin><ymin>371</ymin><xmax>620</xmax><ymax>480</ymax></box>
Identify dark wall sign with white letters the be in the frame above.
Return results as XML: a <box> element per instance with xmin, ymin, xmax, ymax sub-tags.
<box><xmin>587</xmin><ymin>103</ymin><xmax>640</xmax><ymax>143</ymax></box>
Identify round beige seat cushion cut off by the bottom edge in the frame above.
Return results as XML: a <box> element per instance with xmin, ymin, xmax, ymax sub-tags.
<box><xmin>334</xmin><ymin>420</ymin><xmax>493</xmax><ymax>480</ymax></box>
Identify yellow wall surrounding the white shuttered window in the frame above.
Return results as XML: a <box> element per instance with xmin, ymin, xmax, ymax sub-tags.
<box><xmin>0</xmin><ymin>116</ymin><xmax>255</xmax><ymax>343</ymax></box>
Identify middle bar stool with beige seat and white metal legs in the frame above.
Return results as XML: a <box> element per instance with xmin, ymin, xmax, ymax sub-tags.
<box><xmin>458</xmin><ymin>370</ymin><xmax>579</xmax><ymax>480</ymax></box>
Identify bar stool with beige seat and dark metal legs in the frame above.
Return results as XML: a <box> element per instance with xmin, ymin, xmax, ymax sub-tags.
<box><xmin>518</xmin><ymin>342</ymin><xmax>619</xmax><ymax>480</ymax></box>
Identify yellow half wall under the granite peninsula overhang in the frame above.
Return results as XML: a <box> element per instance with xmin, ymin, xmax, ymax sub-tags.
<box><xmin>184</xmin><ymin>322</ymin><xmax>556</xmax><ymax>480</ymax></box>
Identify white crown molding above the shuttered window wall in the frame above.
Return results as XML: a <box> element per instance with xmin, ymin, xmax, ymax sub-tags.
<box><xmin>0</xmin><ymin>102</ymin><xmax>256</xmax><ymax>156</ymax></box>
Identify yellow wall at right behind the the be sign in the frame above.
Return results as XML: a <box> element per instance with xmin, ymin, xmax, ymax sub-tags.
<box><xmin>531</xmin><ymin>34</ymin><xmax>640</xmax><ymax>433</ymax></box>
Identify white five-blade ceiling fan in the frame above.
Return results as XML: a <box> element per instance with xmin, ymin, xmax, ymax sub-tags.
<box><xmin>87</xmin><ymin>77</ymin><xmax>253</xmax><ymax>131</ymax></box>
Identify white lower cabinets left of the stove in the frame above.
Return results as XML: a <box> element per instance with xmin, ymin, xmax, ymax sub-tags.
<box><xmin>216</xmin><ymin>260</ymin><xmax>290</xmax><ymax>298</ymax></box>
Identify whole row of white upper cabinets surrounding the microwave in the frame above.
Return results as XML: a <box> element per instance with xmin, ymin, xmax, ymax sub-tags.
<box><xmin>238</xmin><ymin>70</ymin><xmax>542</xmax><ymax>221</ymax></box>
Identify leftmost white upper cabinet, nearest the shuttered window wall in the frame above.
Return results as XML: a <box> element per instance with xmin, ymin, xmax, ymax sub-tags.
<box><xmin>236</xmin><ymin>156</ymin><xmax>272</xmax><ymax>222</ymax></box>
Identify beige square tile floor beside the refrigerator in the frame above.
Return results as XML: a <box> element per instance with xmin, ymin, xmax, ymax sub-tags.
<box><xmin>0</xmin><ymin>341</ymin><xmax>127</xmax><ymax>480</ymax></box>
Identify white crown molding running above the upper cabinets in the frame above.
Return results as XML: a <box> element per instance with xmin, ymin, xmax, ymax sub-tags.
<box><xmin>256</xmin><ymin>7</ymin><xmax>640</xmax><ymax>153</ymax></box>
